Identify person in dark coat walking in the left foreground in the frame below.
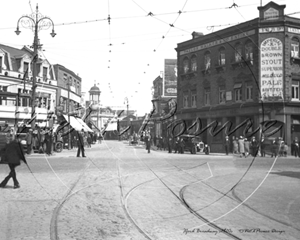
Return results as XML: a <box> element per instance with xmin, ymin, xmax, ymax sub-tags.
<box><xmin>0</xmin><ymin>135</ymin><xmax>27</xmax><ymax>188</ymax></box>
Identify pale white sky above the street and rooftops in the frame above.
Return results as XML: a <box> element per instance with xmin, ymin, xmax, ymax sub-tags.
<box><xmin>0</xmin><ymin>0</ymin><xmax>300</xmax><ymax>115</ymax></box>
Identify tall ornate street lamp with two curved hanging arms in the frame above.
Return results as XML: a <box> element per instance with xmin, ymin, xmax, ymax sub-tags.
<box><xmin>15</xmin><ymin>5</ymin><xmax>56</xmax><ymax>128</ymax></box>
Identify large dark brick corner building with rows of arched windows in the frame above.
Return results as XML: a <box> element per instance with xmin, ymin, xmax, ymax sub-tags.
<box><xmin>176</xmin><ymin>2</ymin><xmax>300</xmax><ymax>152</ymax></box>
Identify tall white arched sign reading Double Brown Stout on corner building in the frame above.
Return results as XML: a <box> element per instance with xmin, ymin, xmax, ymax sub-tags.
<box><xmin>260</xmin><ymin>38</ymin><xmax>283</xmax><ymax>101</ymax></box>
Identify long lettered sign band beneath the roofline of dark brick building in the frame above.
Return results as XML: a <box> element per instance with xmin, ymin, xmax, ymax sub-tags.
<box><xmin>179</xmin><ymin>30</ymin><xmax>255</xmax><ymax>55</ymax></box>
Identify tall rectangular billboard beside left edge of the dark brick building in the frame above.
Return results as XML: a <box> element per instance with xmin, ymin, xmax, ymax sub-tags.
<box><xmin>163</xmin><ymin>59</ymin><xmax>177</xmax><ymax>97</ymax></box>
